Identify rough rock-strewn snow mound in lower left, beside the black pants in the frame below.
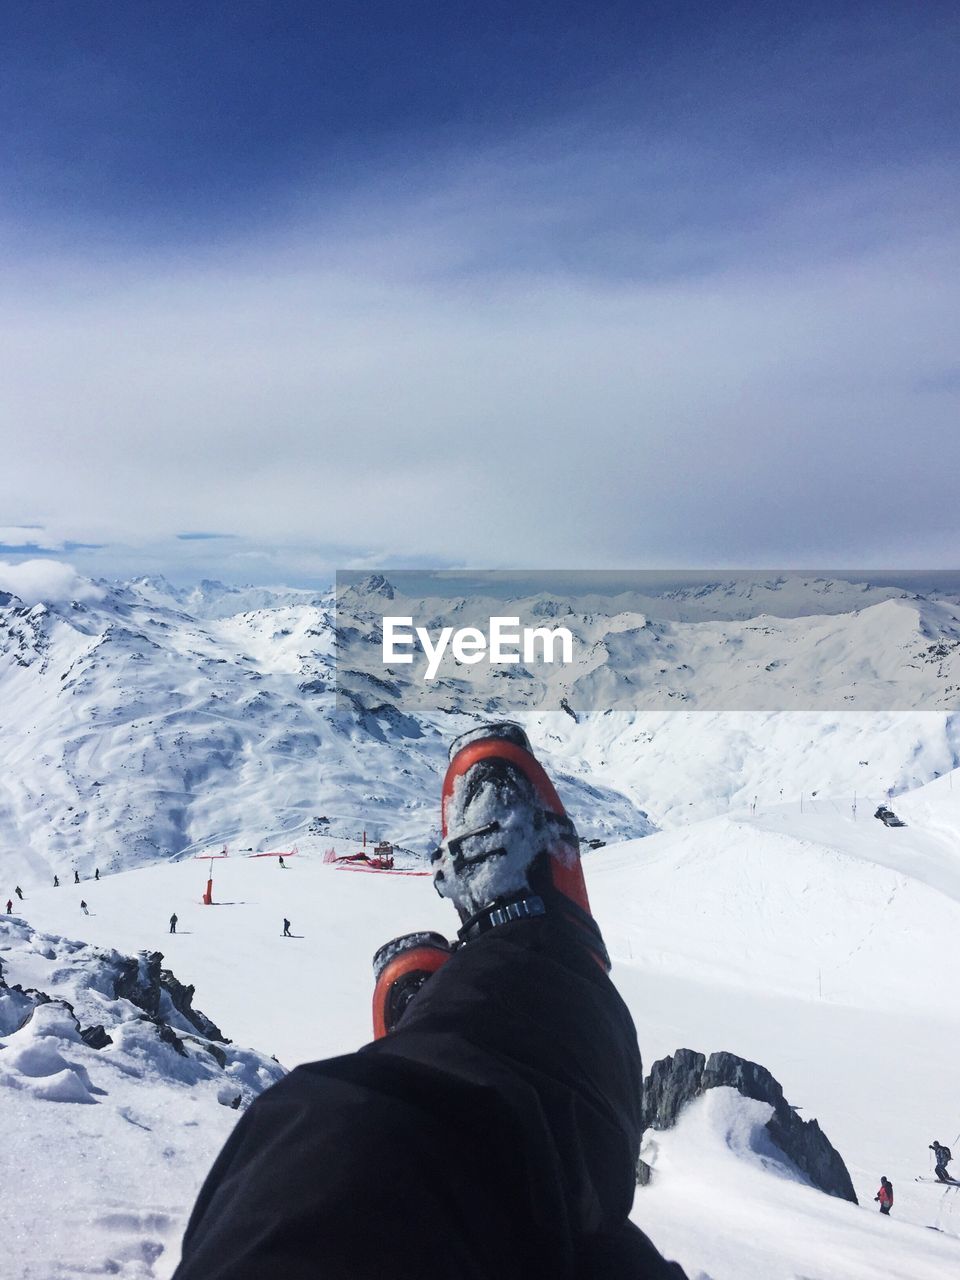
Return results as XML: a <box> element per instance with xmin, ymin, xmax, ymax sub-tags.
<box><xmin>0</xmin><ymin>916</ymin><xmax>283</xmax><ymax>1280</ymax></box>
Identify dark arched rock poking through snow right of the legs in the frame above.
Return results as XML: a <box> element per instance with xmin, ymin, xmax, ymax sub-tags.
<box><xmin>637</xmin><ymin>1048</ymin><xmax>856</xmax><ymax>1204</ymax></box>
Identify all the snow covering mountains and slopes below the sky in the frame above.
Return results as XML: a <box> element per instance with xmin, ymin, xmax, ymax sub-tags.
<box><xmin>0</xmin><ymin>580</ymin><xmax>960</xmax><ymax>1280</ymax></box>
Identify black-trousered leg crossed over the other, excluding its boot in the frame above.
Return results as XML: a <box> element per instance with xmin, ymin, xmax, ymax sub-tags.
<box><xmin>378</xmin><ymin>919</ymin><xmax>641</xmax><ymax>1234</ymax></box>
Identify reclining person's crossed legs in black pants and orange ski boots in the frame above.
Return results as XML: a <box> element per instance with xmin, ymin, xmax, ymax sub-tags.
<box><xmin>177</xmin><ymin>724</ymin><xmax>685</xmax><ymax>1280</ymax></box>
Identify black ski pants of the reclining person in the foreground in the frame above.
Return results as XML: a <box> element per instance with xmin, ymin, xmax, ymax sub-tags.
<box><xmin>177</xmin><ymin>920</ymin><xmax>685</xmax><ymax>1280</ymax></box>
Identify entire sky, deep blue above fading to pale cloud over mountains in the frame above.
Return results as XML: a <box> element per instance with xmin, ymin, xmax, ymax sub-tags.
<box><xmin>0</xmin><ymin>0</ymin><xmax>960</xmax><ymax>588</ymax></box>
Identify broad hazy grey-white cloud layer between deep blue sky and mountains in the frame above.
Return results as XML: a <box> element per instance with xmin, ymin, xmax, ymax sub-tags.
<box><xmin>0</xmin><ymin>132</ymin><xmax>960</xmax><ymax>579</ymax></box>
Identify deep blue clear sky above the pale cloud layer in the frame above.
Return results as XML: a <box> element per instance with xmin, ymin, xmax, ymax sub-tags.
<box><xmin>0</xmin><ymin>0</ymin><xmax>960</xmax><ymax>256</ymax></box>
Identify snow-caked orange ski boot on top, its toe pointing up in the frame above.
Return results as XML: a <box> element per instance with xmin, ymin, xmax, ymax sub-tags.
<box><xmin>431</xmin><ymin>722</ymin><xmax>611</xmax><ymax>970</ymax></box>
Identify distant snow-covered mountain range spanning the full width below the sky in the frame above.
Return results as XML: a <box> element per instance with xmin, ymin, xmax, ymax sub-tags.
<box><xmin>0</xmin><ymin>577</ymin><xmax>960</xmax><ymax>892</ymax></box>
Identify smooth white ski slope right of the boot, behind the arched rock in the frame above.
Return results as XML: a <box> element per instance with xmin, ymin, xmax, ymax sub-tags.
<box><xmin>590</xmin><ymin>778</ymin><xmax>960</xmax><ymax>1259</ymax></box>
